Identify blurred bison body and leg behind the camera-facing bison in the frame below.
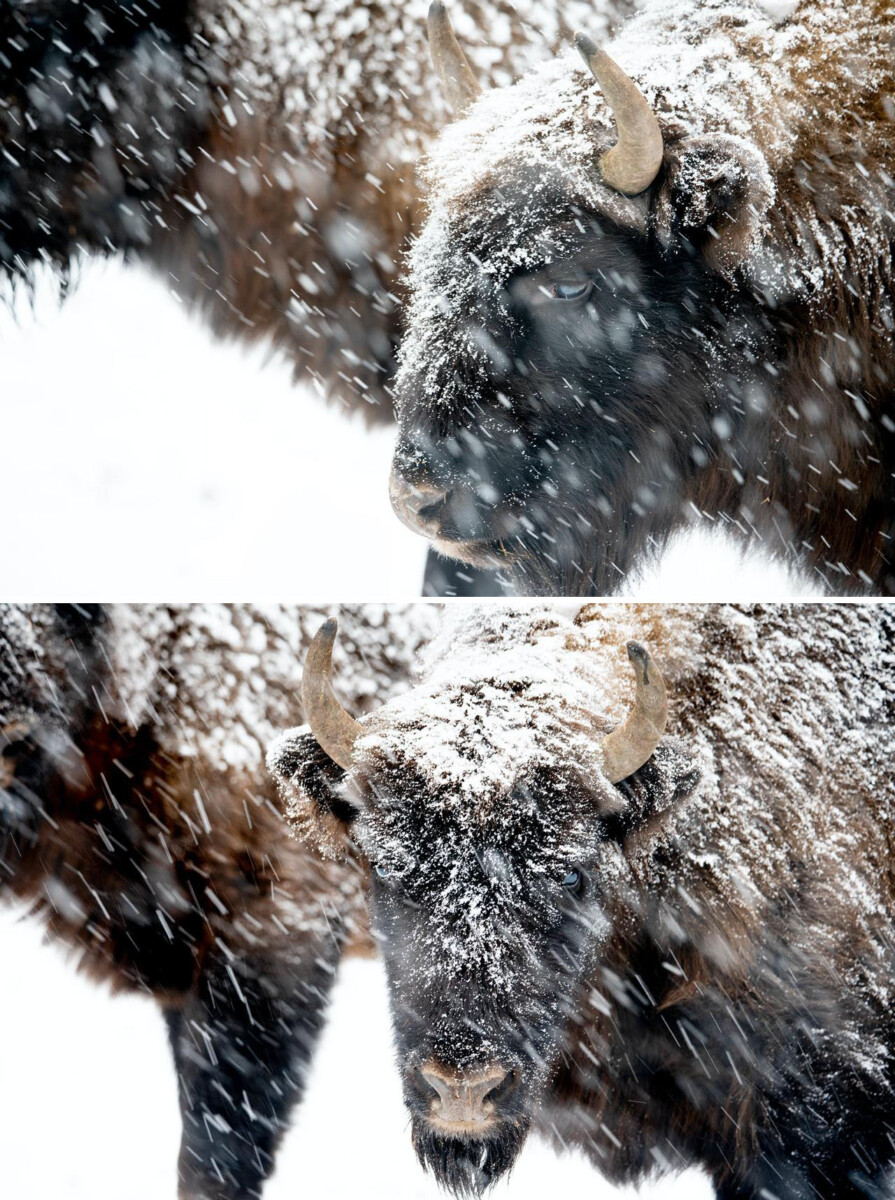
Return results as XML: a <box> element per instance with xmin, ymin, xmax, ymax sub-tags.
<box><xmin>0</xmin><ymin>605</ymin><xmax>438</xmax><ymax>1200</ymax></box>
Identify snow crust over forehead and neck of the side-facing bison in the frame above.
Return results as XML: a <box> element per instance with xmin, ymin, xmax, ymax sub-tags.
<box><xmin>398</xmin><ymin>0</ymin><xmax>890</xmax><ymax>404</ymax></box>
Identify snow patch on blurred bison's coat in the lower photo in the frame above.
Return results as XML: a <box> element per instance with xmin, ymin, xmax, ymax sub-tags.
<box><xmin>104</xmin><ymin>605</ymin><xmax>440</xmax><ymax>773</ymax></box>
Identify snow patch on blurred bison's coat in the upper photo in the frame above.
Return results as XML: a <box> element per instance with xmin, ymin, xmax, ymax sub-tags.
<box><xmin>204</xmin><ymin>0</ymin><xmax>626</xmax><ymax>167</ymax></box>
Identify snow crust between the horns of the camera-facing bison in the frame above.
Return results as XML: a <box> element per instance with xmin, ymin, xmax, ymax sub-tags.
<box><xmin>356</xmin><ymin>605</ymin><xmax>633</xmax><ymax>822</ymax></box>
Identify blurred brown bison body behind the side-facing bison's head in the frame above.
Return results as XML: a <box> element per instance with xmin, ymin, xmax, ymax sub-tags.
<box><xmin>0</xmin><ymin>0</ymin><xmax>630</xmax><ymax>420</ymax></box>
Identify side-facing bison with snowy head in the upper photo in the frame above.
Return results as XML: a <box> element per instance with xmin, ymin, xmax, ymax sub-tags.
<box><xmin>391</xmin><ymin>0</ymin><xmax>895</xmax><ymax>595</ymax></box>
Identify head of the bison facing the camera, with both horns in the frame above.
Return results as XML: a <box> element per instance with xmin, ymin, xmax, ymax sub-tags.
<box><xmin>269</xmin><ymin>612</ymin><xmax>695</xmax><ymax>1194</ymax></box>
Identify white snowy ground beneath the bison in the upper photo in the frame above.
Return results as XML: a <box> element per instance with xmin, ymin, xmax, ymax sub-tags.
<box><xmin>0</xmin><ymin>263</ymin><xmax>806</xmax><ymax>601</ymax></box>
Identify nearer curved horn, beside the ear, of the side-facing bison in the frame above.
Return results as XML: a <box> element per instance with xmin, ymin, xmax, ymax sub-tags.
<box><xmin>575</xmin><ymin>34</ymin><xmax>662</xmax><ymax>196</ymax></box>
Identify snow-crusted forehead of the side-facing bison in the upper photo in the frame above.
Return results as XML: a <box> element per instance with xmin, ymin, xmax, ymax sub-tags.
<box><xmin>397</xmin><ymin>54</ymin><xmax>647</xmax><ymax>404</ymax></box>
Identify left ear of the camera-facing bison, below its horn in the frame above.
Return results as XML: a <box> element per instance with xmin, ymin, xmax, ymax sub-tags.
<box><xmin>268</xmin><ymin>725</ymin><xmax>358</xmax><ymax>858</ymax></box>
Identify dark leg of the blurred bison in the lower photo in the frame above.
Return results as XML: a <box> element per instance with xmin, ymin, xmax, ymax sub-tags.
<box><xmin>161</xmin><ymin>938</ymin><xmax>341</xmax><ymax>1200</ymax></box>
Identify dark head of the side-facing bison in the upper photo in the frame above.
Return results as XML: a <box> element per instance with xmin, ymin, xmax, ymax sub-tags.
<box><xmin>391</xmin><ymin>4</ymin><xmax>774</xmax><ymax>594</ymax></box>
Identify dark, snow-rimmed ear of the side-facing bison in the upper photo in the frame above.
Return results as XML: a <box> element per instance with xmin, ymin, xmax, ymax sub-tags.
<box><xmin>653</xmin><ymin>133</ymin><xmax>775</xmax><ymax>278</ymax></box>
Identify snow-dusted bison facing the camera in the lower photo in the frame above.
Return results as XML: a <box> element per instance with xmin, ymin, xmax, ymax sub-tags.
<box><xmin>269</xmin><ymin>602</ymin><xmax>895</xmax><ymax>1200</ymax></box>
